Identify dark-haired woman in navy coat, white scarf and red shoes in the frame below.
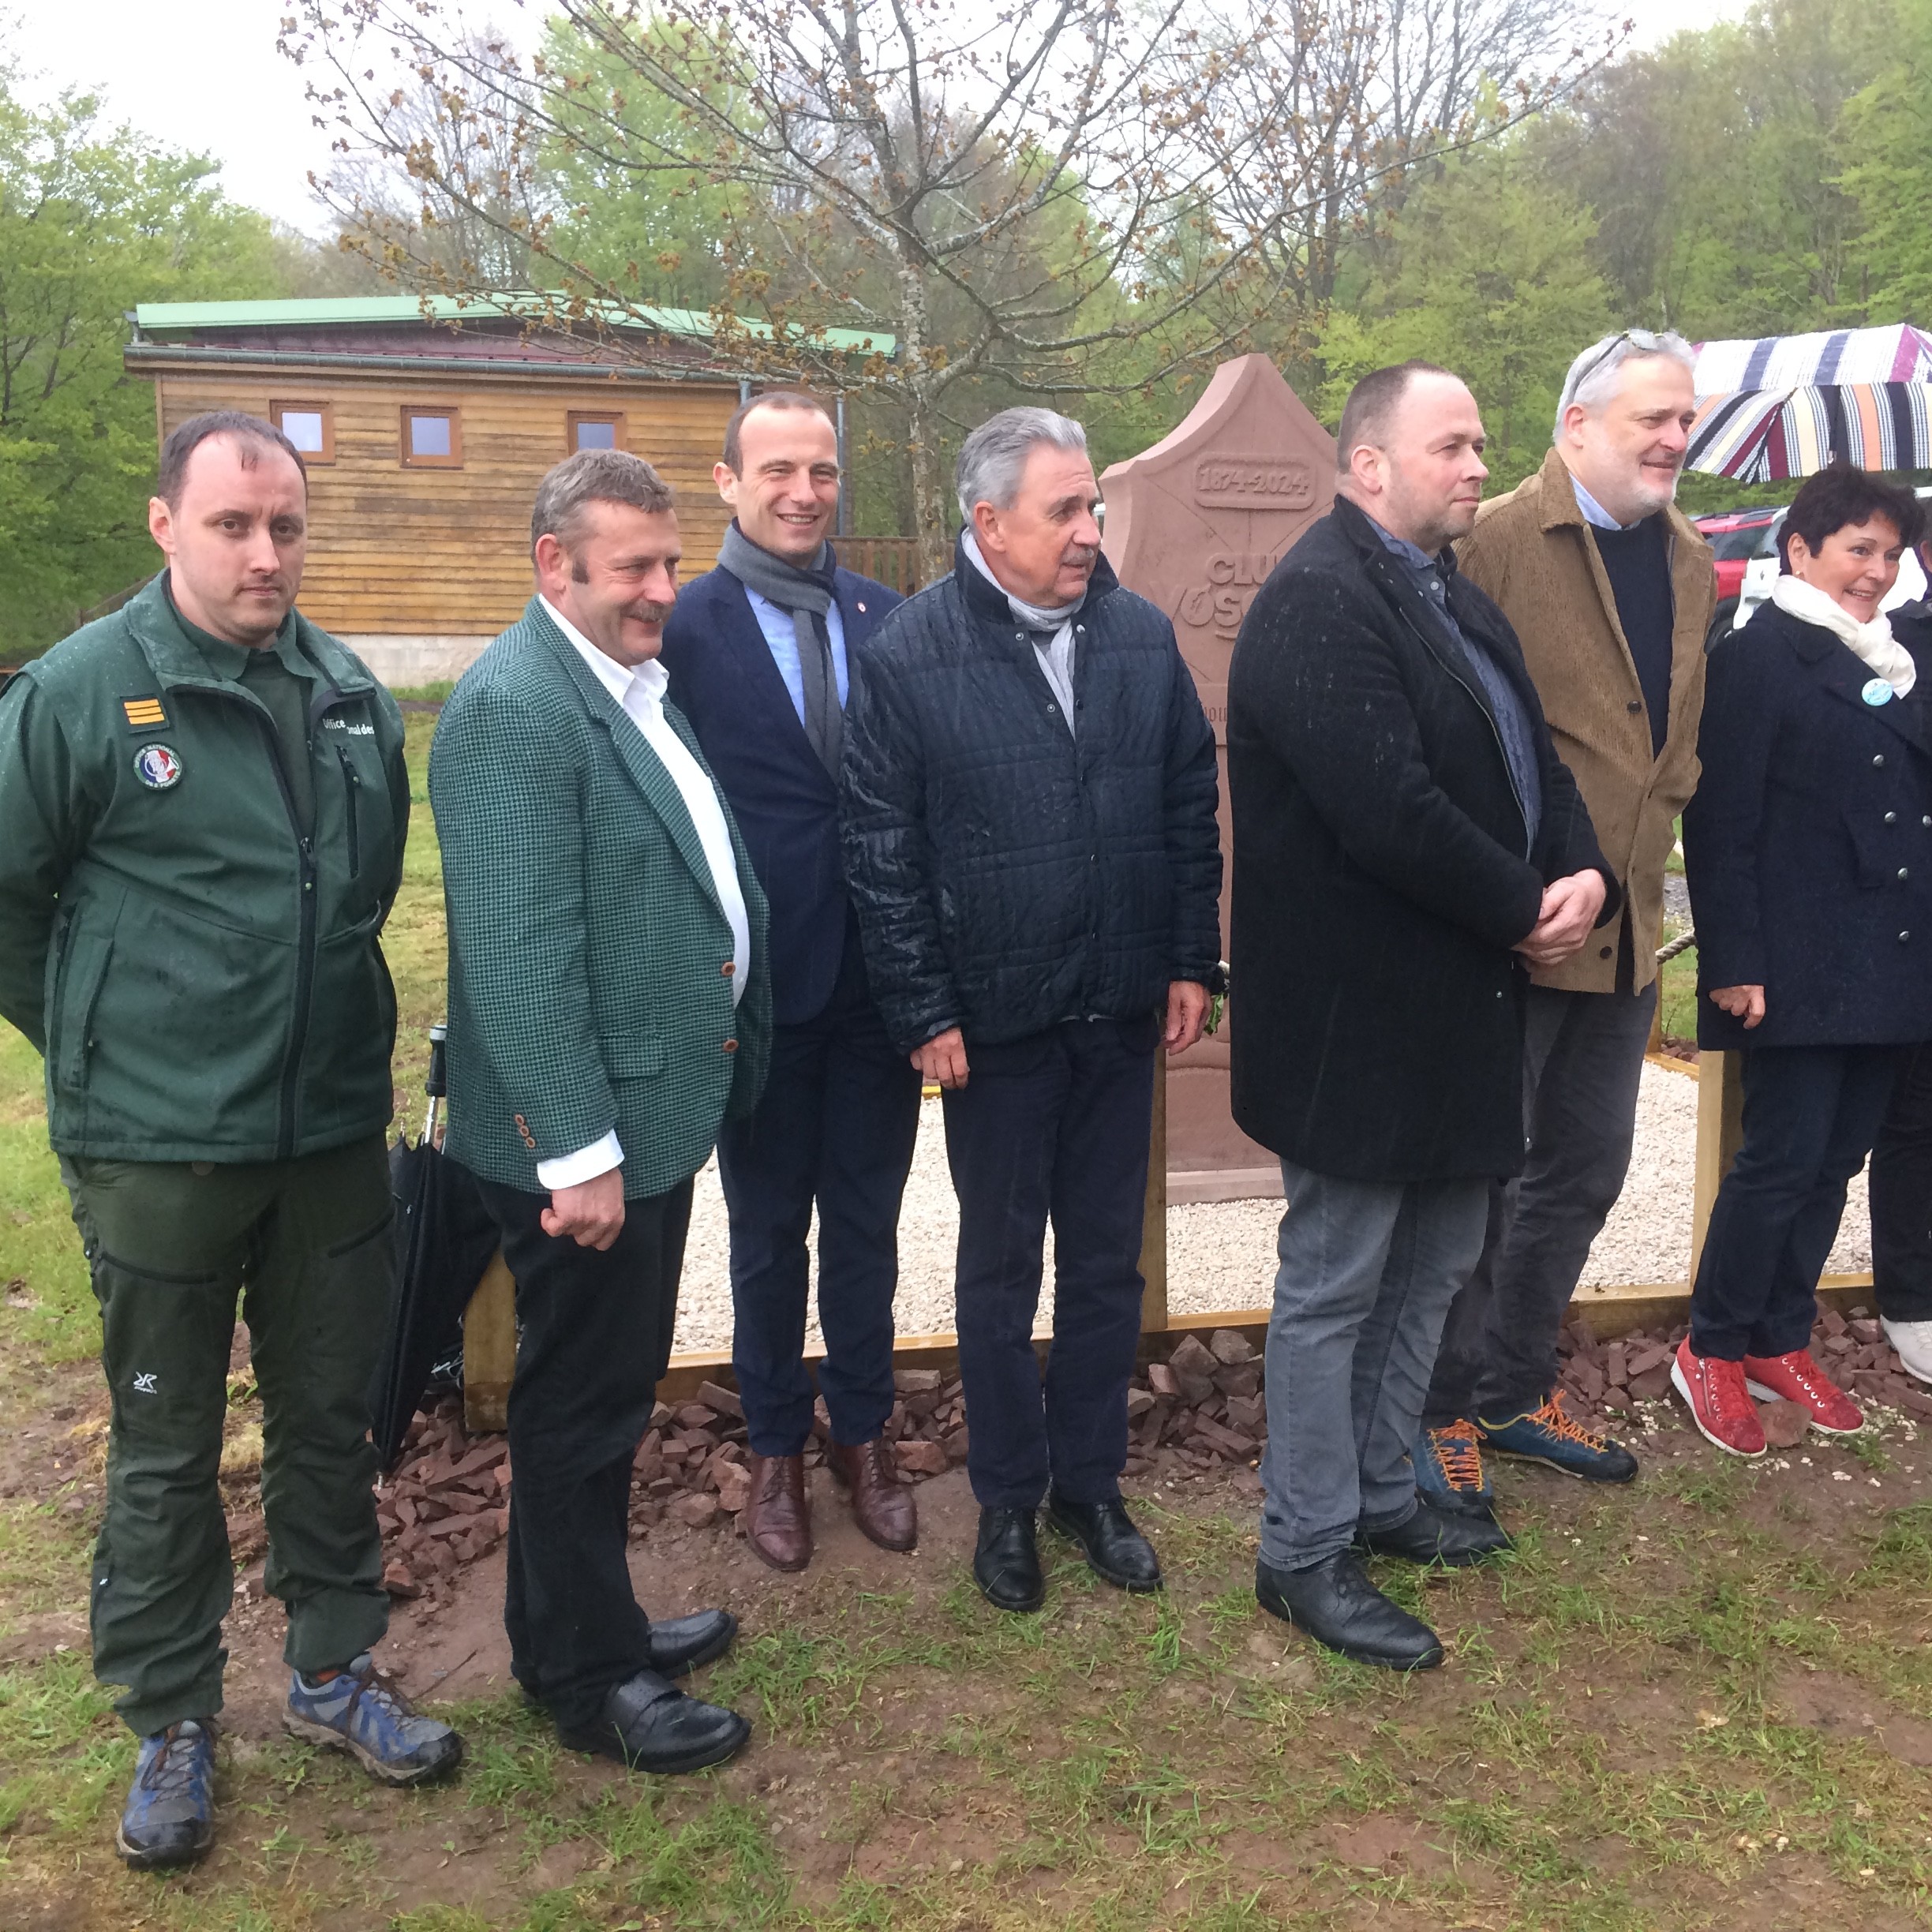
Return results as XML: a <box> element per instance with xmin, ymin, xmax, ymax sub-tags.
<box><xmin>1672</xmin><ymin>467</ymin><xmax>1932</xmax><ymax>1457</ymax></box>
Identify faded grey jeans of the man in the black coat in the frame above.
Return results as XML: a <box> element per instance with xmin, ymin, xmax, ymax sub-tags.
<box><xmin>1262</xmin><ymin>1161</ymin><xmax>1489</xmax><ymax>1569</ymax></box>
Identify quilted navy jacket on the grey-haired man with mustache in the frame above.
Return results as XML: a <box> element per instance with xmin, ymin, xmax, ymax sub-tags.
<box><xmin>841</xmin><ymin>533</ymin><xmax>1221</xmax><ymax>1051</ymax></box>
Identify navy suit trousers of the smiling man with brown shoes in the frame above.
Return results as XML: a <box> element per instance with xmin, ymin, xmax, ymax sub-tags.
<box><xmin>719</xmin><ymin>919</ymin><xmax>919</xmax><ymax>1455</ymax></box>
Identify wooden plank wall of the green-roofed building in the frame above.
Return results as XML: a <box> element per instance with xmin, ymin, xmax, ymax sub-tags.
<box><xmin>155</xmin><ymin>369</ymin><xmax>738</xmax><ymax>638</ymax></box>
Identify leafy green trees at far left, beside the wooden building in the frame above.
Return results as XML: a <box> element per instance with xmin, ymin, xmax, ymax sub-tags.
<box><xmin>0</xmin><ymin>64</ymin><xmax>288</xmax><ymax>659</ymax></box>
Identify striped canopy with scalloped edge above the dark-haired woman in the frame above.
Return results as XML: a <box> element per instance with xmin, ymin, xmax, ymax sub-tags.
<box><xmin>1689</xmin><ymin>323</ymin><xmax>1932</xmax><ymax>483</ymax></box>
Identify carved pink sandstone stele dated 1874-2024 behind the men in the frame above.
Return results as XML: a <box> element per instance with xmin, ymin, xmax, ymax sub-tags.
<box><xmin>1101</xmin><ymin>355</ymin><xmax>1335</xmax><ymax>1202</ymax></box>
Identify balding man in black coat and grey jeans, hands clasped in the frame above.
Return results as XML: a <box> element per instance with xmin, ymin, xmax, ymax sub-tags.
<box><xmin>1226</xmin><ymin>363</ymin><xmax>1617</xmax><ymax>1669</ymax></box>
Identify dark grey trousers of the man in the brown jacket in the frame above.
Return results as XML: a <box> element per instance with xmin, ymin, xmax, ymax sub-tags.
<box><xmin>1422</xmin><ymin>964</ymin><xmax>1657</xmax><ymax>1428</ymax></box>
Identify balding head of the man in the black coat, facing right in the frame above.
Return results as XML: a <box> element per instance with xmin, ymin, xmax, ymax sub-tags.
<box><xmin>1335</xmin><ymin>363</ymin><xmax>1489</xmax><ymax>552</ymax></box>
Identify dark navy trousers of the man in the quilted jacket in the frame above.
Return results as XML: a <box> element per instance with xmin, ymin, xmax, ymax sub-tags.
<box><xmin>945</xmin><ymin>1014</ymin><xmax>1159</xmax><ymax>1509</ymax></box>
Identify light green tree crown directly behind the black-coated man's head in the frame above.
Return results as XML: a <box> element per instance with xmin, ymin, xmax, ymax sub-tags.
<box><xmin>1321</xmin><ymin>147</ymin><xmax>1612</xmax><ymax>492</ymax></box>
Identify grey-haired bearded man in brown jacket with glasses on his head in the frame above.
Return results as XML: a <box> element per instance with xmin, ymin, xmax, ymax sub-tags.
<box><xmin>1414</xmin><ymin>328</ymin><xmax>1716</xmax><ymax>1513</ymax></box>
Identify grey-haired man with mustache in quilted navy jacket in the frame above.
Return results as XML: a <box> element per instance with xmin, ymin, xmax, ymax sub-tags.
<box><xmin>844</xmin><ymin>408</ymin><xmax>1221</xmax><ymax>1612</ymax></box>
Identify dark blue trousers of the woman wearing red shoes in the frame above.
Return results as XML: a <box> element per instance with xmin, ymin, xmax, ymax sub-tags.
<box><xmin>1690</xmin><ymin>1047</ymin><xmax>1905</xmax><ymax>1362</ymax></box>
